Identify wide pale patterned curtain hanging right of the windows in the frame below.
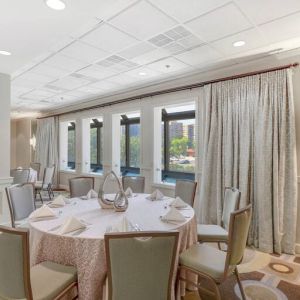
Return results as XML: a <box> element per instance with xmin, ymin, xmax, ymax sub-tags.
<box><xmin>198</xmin><ymin>70</ymin><xmax>297</xmax><ymax>253</ymax></box>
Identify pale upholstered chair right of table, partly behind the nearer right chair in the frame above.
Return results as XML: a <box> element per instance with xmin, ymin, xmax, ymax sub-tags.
<box><xmin>197</xmin><ymin>187</ymin><xmax>241</xmax><ymax>249</ymax></box>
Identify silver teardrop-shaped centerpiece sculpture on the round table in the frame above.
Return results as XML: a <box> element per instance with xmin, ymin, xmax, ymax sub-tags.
<box><xmin>98</xmin><ymin>171</ymin><xmax>128</xmax><ymax>212</ymax></box>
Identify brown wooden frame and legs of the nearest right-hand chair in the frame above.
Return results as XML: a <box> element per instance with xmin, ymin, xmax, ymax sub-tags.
<box><xmin>177</xmin><ymin>205</ymin><xmax>251</xmax><ymax>300</ymax></box>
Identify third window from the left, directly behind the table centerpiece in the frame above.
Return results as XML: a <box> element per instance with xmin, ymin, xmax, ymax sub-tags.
<box><xmin>120</xmin><ymin>113</ymin><xmax>140</xmax><ymax>176</ymax></box>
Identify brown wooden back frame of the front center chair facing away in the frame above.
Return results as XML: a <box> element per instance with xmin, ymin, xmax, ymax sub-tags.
<box><xmin>104</xmin><ymin>231</ymin><xmax>179</xmax><ymax>300</ymax></box>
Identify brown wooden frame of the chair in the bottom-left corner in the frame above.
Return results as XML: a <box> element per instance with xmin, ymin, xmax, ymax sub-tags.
<box><xmin>0</xmin><ymin>226</ymin><xmax>78</xmax><ymax>300</ymax></box>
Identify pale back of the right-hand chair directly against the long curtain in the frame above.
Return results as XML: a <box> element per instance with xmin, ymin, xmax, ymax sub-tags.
<box><xmin>222</xmin><ymin>187</ymin><xmax>241</xmax><ymax>231</ymax></box>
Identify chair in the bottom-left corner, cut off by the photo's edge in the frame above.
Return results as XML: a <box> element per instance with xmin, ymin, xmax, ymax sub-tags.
<box><xmin>0</xmin><ymin>226</ymin><xmax>78</xmax><ymax>300</ymax></box>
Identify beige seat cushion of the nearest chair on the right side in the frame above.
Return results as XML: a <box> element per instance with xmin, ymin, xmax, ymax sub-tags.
<box><xmin>179</xmin><ymin>244</ymin><xmax>226</xmax><ymax>281</ymax></box>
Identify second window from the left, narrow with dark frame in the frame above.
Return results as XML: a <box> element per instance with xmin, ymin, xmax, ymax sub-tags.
<box><xmin>90</xmin><ymin>118</ymin><xmax>103</xmax><ymax>173</ymax></box>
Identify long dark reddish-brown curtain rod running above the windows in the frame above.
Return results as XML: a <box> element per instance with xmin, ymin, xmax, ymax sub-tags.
<box><xmin>38</xmin><ymin>62</ymin><xmax>299</xmax><ymax>119</ymax></box>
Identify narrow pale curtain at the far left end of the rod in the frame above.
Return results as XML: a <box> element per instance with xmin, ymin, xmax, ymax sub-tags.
<box><xmin>35</xmin><ymin>117</ymin><xmax>58</xmax><ymax>184</ymax></box>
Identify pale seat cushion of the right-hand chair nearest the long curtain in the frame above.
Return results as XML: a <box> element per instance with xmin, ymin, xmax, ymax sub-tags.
<box><xmin>197</xmin><ymin>224</ymin><xmax>228</xmax><ymax>242</ymax></box>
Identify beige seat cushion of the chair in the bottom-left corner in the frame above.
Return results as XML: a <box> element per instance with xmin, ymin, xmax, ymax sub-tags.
<box><xmin>30</xmin><ymin>261</ymin><xmax>77</xmax><ymax>300</ymax></box>
